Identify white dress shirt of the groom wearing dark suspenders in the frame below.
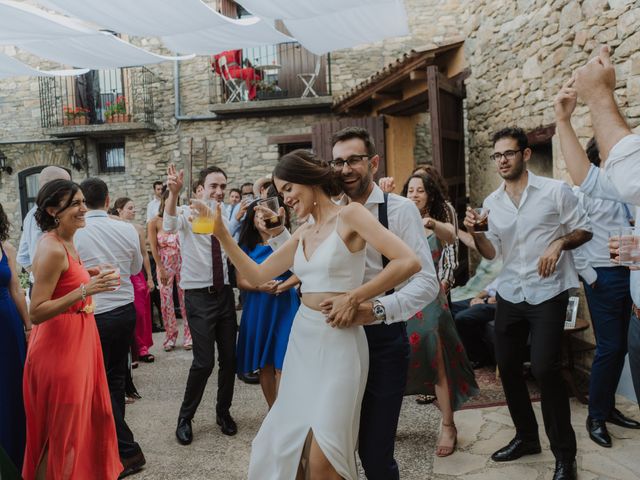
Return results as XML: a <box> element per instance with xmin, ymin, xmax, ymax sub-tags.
<box><xmin>269</xmin><ymin>184</ymin><xmax>440</xmax><ymax>324</ymax></box>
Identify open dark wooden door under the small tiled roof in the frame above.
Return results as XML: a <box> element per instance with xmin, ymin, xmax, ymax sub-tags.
<box><xmin>427</xmin><ymin>65</ymin><xmax>469</xmax><ymax>285</ymax></box>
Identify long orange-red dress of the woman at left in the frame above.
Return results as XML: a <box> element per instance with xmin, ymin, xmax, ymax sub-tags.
<box><xmin>22</xmin><ymin>239</ymin><xmax>122</xmax><ymax>480</ymax></box>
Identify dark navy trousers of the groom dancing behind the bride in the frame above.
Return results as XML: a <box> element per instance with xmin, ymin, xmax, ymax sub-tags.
<box><xmin>358</xmin><ymin>322</ymin><xmax>409</xmax><ymax>480</ymax></box>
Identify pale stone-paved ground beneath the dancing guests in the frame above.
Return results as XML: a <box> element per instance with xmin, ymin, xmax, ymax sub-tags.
<box><xmin>127</xmin><ymin>333</ymin><xmax>640</xmax><ymax>480</ymax></box>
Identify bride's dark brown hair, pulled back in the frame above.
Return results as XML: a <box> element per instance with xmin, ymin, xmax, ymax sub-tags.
<box><xmin>273</xmin><ymin>149</ymin><xmax>342</xmax><ymax>197</ymax></box>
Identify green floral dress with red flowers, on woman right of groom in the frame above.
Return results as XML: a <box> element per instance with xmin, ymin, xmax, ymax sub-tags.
<box><xmin>405</xmin><ymin>234</ymin><xmax>479</xmax><ymax>410</ymax></box>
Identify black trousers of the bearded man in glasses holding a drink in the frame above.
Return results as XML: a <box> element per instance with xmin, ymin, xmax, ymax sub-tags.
<box><xmin>495</xmin><ymin>291</ymin><xmax>576</xmax><ymax>461</ymax></box>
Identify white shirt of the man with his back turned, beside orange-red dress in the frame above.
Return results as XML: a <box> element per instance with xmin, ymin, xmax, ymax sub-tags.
<box><xmin>74</xmin><ymin>210</ymin><xmax>142</xmax><ymax>315</ymax></box>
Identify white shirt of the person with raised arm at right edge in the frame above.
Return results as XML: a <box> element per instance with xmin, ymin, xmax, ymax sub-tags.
<box><xmin>580</xmin><ymin>135</ymin><xmax>640</xmax><ymax>305</ymax></box>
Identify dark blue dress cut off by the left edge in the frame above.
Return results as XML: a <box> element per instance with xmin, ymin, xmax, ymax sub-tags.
<box><xmin>0</xmin><ymin>250</ymin><xmax>27</xmax><ymax>471</ymax></box>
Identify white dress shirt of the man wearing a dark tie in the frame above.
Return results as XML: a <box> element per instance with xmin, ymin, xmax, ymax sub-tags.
<box><xmin>162</xmin><ymin>207</ymin><xmax>229</xmax><ymax>290</ymax></box>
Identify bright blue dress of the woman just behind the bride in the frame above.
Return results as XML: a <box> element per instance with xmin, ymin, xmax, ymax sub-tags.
<box><xmin>237</xmin><ymin>245</ymin><xmax>300</xmax><ymax>374</ymax></box>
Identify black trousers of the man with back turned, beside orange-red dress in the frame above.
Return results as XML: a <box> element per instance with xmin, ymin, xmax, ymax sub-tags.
<box><xmin>95</xmin><ymin>303</ymin><xmax>141</xmax><ymax>458</ymax></box>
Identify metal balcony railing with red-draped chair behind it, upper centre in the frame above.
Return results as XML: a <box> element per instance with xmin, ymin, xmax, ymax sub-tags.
<box><xmin>210</xmin><ymin>42</ymin><xmax>331</xmax><ymax>104</ymax></box>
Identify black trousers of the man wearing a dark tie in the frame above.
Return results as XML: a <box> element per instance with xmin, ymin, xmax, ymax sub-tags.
<box><xmin>179</xmin><ymin>285</ymin><xmax>238</xmax><ymax>419</ymax></box>
